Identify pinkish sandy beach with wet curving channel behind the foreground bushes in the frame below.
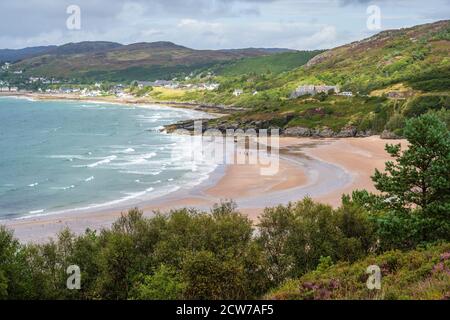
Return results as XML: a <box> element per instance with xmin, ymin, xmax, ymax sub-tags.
<box><xmin>0</xmin><ymin>125</ymin><xmax>406</xmax><ymax>242</ymax></box>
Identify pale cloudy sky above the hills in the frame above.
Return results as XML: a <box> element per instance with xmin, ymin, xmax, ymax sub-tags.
<box><xmin>0</xmin><ymin>0</ymin><xmax>450</xmax><ymax>50</ymax></box>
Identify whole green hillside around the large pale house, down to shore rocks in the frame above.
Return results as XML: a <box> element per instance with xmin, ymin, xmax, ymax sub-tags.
<box><xmin>166</xmin><ymin>20</ymin><xmax>450</xmax><ymax>135</ymax></box>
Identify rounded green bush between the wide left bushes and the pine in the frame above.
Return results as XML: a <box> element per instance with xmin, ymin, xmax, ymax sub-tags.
<box><xmin>259</xmin><ymin>198</ymin><xmax>375</xmax><ymax>283</ymax></box>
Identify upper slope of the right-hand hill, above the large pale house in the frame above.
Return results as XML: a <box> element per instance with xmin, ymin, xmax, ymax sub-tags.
<box><xmin>286</xmin><ymin>20</ymin><xmax>450</xmax><ymax>93</ymax></box>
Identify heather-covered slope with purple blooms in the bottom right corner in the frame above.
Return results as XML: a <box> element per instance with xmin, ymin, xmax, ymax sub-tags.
<box><xmin>266</xmin><ymin>243</ymin><xmax>450</xmax><ymax>300</ymax></box>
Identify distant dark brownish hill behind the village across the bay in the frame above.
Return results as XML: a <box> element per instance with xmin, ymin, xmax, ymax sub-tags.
<box><xmin>5</xmin><ymin>41</ymin><xmax>296</xmax><ymax>81</ymax></box>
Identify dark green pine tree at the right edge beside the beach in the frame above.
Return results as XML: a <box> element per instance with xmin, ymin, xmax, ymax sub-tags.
<box><xmin>353</xmin><ymin>114</ymin><xmax>450</xmax><ymax>249</ymax></box>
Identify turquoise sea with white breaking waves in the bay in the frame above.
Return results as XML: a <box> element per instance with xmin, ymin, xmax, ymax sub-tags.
<box><xmin>0</xmin><ymin>97</ymin><xmax>214</xmax><ymax>219</ymax></box>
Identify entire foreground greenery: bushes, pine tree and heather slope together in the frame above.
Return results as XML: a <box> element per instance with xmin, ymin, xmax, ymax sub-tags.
<box><xmin>0</xmin><ymin>113</ymin><xmax>450</xmax><ymax>299</ymax></box>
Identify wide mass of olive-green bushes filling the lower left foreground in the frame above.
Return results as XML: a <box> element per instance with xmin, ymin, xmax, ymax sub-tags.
<box><xmin>0</xmin><ymin>203</ymin><xmax>270</xmax><ymax>299</ymax></box>
